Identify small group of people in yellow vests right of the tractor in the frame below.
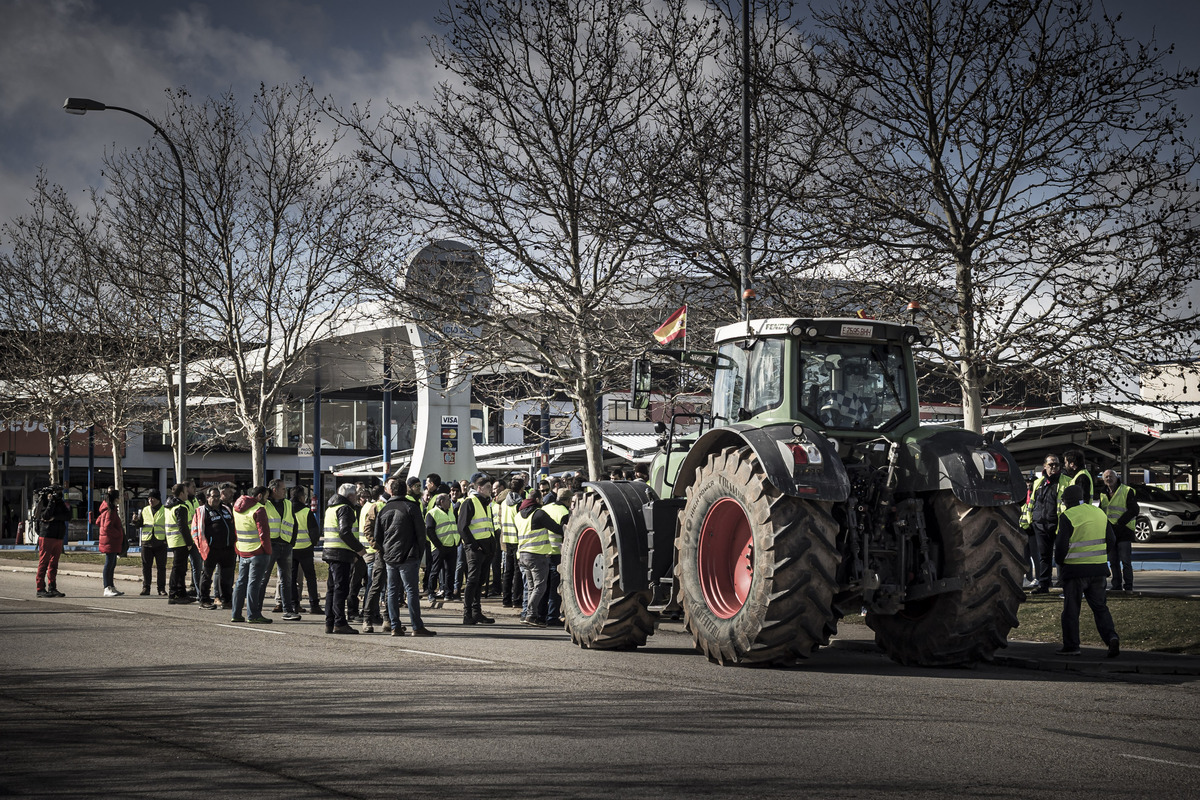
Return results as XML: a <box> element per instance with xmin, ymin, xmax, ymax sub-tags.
<box><xmin>1021</xmin><ymin>450</ymin><xmax>1139</xmax><ymax>657</ymax></box>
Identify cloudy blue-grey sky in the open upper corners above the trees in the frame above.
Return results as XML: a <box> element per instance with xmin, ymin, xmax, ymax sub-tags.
<box><xmin>0</xmin><ymin>0</ymin><xmax>1200</xmax><ymax>231</ymax></box>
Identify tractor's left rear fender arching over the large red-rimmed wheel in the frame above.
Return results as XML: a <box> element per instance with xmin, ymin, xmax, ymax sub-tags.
<box><xmin>671</xmin><ymin>422</ymin><xmax>850</xmax><ymax>503</ymax></box>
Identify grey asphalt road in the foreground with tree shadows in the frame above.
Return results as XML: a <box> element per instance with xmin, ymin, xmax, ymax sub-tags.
<box><xmin>0</xmin><ymin>573</ymin><xmax>1200</xmax><ymax>800</ymax></box>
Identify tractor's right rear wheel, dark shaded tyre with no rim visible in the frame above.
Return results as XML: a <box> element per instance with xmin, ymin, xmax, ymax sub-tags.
<box><xmin>866</xmin><ymin>491</ymin><xmax>1025</xmax><ymax>667</ymax></box>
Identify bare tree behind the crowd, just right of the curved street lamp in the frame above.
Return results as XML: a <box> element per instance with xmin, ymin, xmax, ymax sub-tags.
<box><xmin>101</xmin><ymin>84</ymin><xmax>392</xmax><ymax>482</ymax></box>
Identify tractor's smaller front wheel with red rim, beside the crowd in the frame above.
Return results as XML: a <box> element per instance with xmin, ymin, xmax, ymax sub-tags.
<box><xmin>558</xmin><ymin>492</ymin><xmax>658</xmax><ymax>650</ymax></box>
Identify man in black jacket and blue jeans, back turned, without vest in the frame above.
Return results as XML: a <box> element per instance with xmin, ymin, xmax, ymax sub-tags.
<box><xmin>376</xmin><ymin>479</ymin><xmax>436</xmax><ymax>636</ymax></box>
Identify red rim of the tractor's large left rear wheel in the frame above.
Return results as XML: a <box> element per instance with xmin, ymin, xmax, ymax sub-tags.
<box><xmin>696</xmin><ymin>498</ymin><xmax>754</xmax><ymax>619</ymax></box>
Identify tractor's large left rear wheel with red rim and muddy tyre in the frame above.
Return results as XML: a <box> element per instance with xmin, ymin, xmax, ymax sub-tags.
<box><xmin>676</xmin><ymin>447</ymin><xmax>839</xmax><ymax>664</ymax></box>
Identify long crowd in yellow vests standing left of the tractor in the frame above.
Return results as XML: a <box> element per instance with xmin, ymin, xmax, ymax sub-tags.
<box><xmin>29</xmin><ymin>473</ymin><xmax>585</xmax><ymax>636</ymax></box>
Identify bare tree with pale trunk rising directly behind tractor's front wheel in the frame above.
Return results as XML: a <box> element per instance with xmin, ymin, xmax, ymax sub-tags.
<box><xmin>334</xmin><ymin>0</ymin><xmax>686</xmax><ymax>475</ymax></box>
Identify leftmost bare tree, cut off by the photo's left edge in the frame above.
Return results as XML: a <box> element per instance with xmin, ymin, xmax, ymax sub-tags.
<box><xmin>0</xmin><ymin>173</ymin><xmax>89</xmax><ymax>485</ymax></box>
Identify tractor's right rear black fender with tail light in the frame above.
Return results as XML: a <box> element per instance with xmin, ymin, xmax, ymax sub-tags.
<box><xmin>900</xmin><ymin>428</ymin><xmax>1025</xmax><ymax>507</ymax></box>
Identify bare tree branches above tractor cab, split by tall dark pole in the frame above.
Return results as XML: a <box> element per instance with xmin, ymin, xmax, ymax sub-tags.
<box><xmin>648</xmin><ymin>0</ymin><xmax>849</xmax><ymax>324</ymax></box>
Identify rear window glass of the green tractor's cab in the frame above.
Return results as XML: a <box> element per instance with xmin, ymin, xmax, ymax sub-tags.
<box><xmin>800</xmin><ymin>342</ymin><xmax>908</xmax><ymax>431</ymax></box>
